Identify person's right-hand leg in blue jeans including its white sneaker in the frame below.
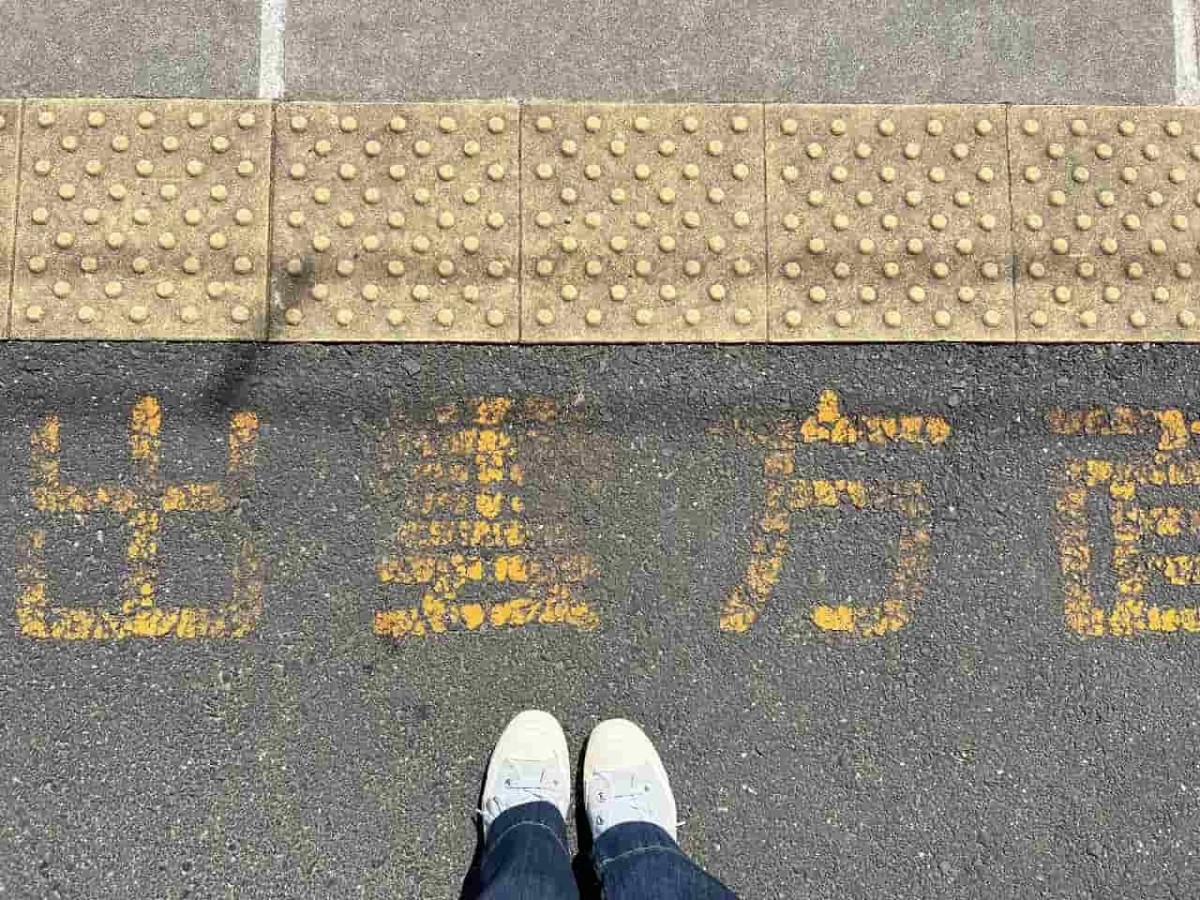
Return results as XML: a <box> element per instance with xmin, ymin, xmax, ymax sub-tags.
<box><xmin>583</xmin><ymin>719</ymin><xmax>736</xmax><ymax>900</ymax></box>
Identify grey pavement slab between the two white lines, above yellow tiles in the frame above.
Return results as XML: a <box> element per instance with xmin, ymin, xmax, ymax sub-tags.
<box><xmin>284</xmin><ymin>0</ymin><xmax>1174</xmax><ymax>103</ymax></box>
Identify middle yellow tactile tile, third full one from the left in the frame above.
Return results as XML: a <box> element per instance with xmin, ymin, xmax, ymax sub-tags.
<box><xmin>521</xmin><ymin>103</ymin><xmax>767</xmax><ymax>342</ymax></box>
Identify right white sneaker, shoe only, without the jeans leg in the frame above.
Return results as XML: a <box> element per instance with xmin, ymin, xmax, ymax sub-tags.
<box><xmin>583</xmin><ymin>719</ymin><xmax>678</xmax><ymax>840</ymax></box>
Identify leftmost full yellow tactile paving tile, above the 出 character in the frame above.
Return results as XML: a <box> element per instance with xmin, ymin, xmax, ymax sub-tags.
<box><xmin>12</xmin><ymin>100</ymin><xmax>271</xmax><ymax>340</ymax></box>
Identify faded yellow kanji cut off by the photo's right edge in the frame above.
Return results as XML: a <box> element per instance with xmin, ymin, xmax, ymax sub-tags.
<box><xmin>1049</xmin><ymin>407</ymin><xmax>1200</xmax><ymax>637</ymax></box>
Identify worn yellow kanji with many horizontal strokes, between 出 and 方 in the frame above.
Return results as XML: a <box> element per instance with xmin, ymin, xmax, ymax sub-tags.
<box><xmin>374</xmin><ymin>397</ymin><xmax>598</xmax><ymax>638</ymax></box>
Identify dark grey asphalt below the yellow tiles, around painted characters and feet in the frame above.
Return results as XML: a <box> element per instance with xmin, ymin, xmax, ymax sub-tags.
<box><xmin>0</xmin><ymin>343</ymin><xmax>1200</xmax><ymax>899</ymax></box>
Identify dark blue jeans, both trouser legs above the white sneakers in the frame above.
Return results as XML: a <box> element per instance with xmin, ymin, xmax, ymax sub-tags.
<box><xmin>466</xmin><ymin>803</ymin><xmax>737</xmax><ymax>900</ymax></box>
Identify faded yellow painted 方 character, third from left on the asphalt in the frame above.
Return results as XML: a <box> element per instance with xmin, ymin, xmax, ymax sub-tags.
<box><xmin>720</xmin><ymin>391</ymin><xmax>950</xmax><ymax>637</ymax></box>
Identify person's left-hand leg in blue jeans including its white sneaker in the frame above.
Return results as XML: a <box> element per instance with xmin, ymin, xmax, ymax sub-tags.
<box><xmin>468</xmin><ymin>710</ymin><xmax>580</xmax><ymax>900</ymax></box>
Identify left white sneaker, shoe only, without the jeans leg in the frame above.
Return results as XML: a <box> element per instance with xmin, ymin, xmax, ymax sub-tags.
<box><xmin>480</xmin><ymin>709</ymin><xmax>571</xmax><ymax>838</ymax></box>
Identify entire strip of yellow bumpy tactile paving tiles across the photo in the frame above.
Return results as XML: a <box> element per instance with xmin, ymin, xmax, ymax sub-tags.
<box><xmin>0</xmin><ymin>98</ymin><xmax>1200</xmax><ymax>343</ymax></box>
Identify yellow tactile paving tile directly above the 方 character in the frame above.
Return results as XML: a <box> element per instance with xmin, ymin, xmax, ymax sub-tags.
<box><xmin>767</xmin><ymin>106</ymin><xmax>1014</xmax><ymax>341</ymax></box>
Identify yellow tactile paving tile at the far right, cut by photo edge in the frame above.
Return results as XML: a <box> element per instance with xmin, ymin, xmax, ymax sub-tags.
<box><xmin>1009</xmin><ymin>107</ymin><xmax>1200</xmax><ymax>341</ymax></box>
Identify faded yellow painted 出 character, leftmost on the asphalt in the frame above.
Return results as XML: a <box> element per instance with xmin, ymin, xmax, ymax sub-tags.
<box><xmin>16</xmin><ymin>397</ymin><xmax>263</xmax><ymax>641</ymax></box>
